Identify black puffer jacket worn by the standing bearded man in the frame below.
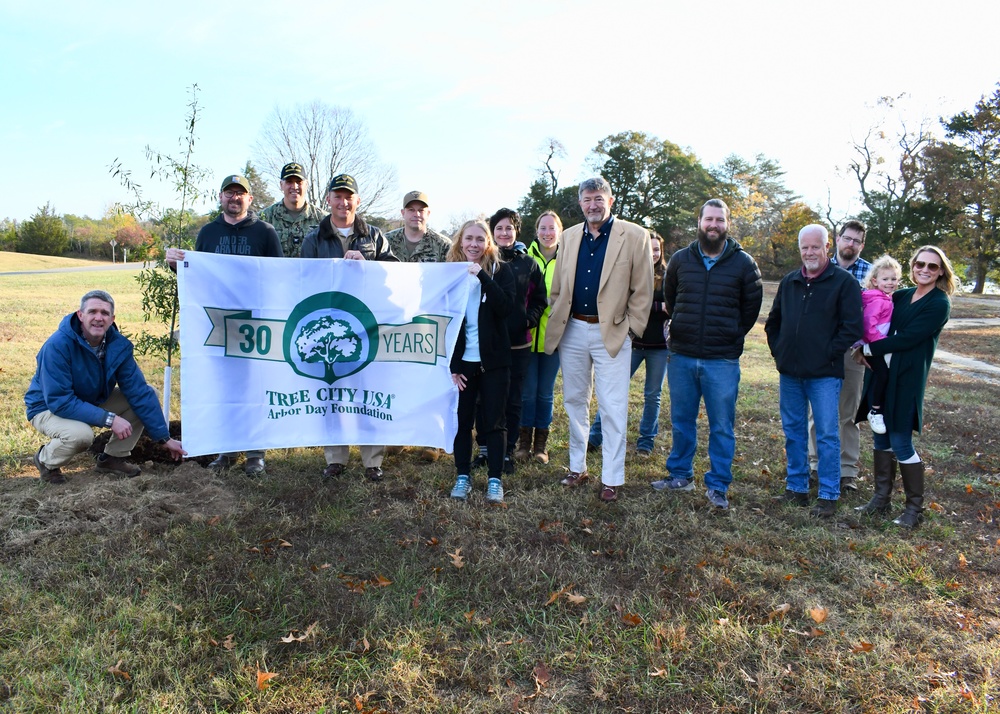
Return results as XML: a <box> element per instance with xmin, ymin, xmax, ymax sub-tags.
<box><xmin>663</xmin><ymin>238</ymin><xmax>764</xmax><ymax>359</ymax></box>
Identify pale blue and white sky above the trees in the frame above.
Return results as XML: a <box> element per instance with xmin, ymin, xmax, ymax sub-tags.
<box><xmin>0</xmin><ymin>0</ymin><xmax>1000</xmax><ymax>228</ymax></box>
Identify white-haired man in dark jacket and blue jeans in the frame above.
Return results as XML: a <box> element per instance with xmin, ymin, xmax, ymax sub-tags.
<box><xmin>764</xmin><ymin>224</ymin><xmax>863</xmax><ymax>518</ymax></box>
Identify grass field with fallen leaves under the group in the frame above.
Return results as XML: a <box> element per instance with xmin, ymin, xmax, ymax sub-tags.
<box><xmin>0</xmin><ymin>258</ymin><xmax>1000</xmax><ymax>714</ymax></box>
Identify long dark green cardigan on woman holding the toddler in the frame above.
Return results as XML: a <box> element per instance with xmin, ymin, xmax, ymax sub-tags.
<box><xmin>861</xmin><ymin>288</ymin><xmax>951</xmax><ymax>433</ymax></box>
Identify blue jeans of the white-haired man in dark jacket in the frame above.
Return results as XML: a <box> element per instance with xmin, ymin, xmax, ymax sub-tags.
<box><xmin>778</xmin><ymin>374</ymin><xmax>840</xmax><ymax>501</ymax></box>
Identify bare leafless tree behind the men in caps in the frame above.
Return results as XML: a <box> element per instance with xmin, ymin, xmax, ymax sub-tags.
<box><xmin>253</xmin><ymin>100</ymin><xmax>396</xmax><ymax>214</ymax></box>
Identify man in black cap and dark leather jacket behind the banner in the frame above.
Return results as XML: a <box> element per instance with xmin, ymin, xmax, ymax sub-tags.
<box><xmin>302</xmin><ymin>174</ymin><xmax>398</xmax><ymax>481</ymax></box>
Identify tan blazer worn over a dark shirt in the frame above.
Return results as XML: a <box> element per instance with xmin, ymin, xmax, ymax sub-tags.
<box><xmin>545</xmin><ymin>218</ymin><xmax>653</xmax><ymax>357</ymax></box>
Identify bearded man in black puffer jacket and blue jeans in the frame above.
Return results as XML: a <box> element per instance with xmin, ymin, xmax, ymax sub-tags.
<box><xmin>652</xmin><ymin>198</ymin><xmax>764</xmax><ymax>510</ymax></box>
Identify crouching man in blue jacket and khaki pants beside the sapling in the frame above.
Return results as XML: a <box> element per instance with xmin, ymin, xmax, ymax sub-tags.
<box><xmin>24</xmin><ymin>290</ymin><xmax>187</xmax><ymax>483</ymax></box>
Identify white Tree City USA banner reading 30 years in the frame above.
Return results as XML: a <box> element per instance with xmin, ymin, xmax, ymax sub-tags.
<box><xmin>177</xmin><ymin>251</ymin><xmax>476</xmax><ymax>456</ymax></box>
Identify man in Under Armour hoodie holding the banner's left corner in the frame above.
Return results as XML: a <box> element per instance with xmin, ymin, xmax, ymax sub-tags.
<box><xmin>166</xmin><ymin>174</ymin><xmax>284</xmax><ymax>477</ymax></box>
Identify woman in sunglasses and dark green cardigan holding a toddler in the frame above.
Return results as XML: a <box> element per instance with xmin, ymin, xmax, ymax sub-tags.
<box><xmin>855</xmin><ymin>245</ymin><xmax>955</xmax><ymax>528</ymax></box>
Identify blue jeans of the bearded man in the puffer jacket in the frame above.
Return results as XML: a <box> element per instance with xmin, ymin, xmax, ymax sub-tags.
<box><xmin>667</xmin><ymin>352</ymin><xmax>740</xmax><ymax>493</ymax></box>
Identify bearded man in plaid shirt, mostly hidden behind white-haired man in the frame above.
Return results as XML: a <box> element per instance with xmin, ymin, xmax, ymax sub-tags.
<box><xmin>809</xmin><ymin>220</ymin><xmax>872</xmax><ymax>491</ymax></box>
